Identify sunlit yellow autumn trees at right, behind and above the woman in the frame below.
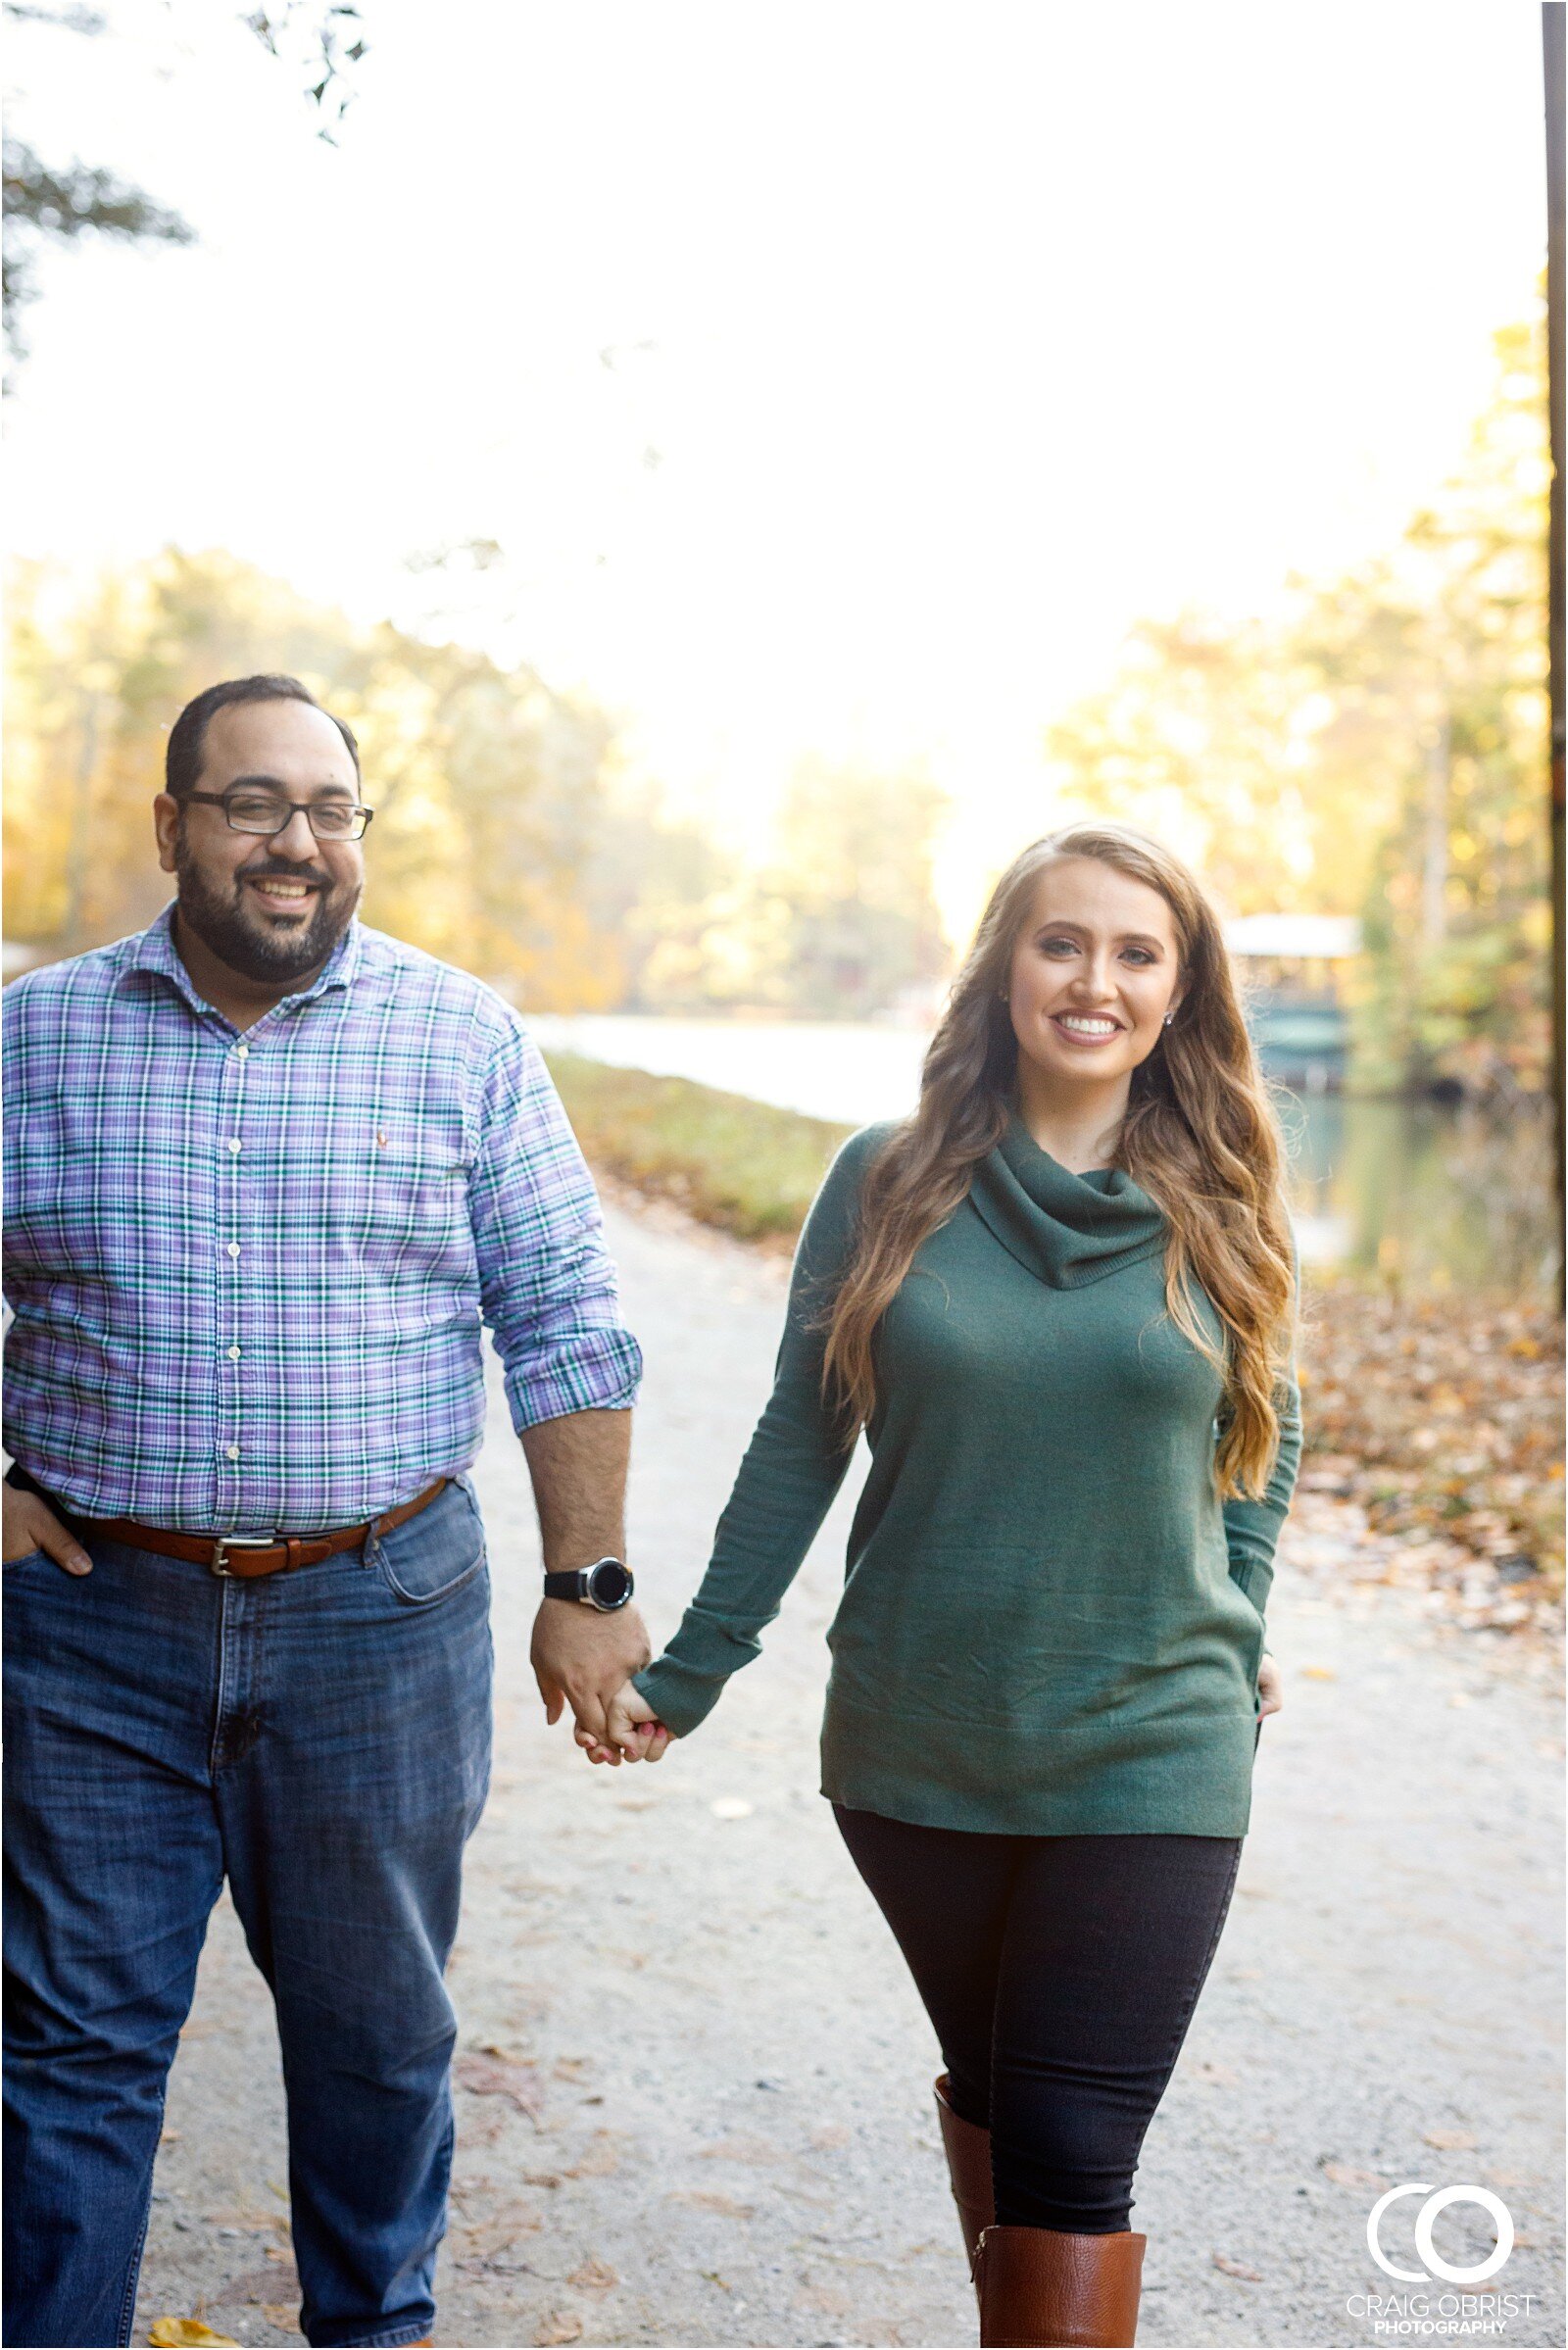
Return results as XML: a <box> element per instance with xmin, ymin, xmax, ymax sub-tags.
<box><xmin>1046</xmin><ymin>324</ymin><xmax>1549</xmax><ymax>1093</ymax></box>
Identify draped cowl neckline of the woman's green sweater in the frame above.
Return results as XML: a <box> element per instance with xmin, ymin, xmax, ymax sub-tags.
<box><xmin>968</xmin><ymin>1111</ymin><xmax>1166</xmax><ymax>1291</ymax></box>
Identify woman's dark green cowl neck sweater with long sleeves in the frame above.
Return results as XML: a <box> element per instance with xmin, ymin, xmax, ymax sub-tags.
<box><xmin>637</xmin><ymin>1118</ymin><xmax>1300</xmax><ymax>1836</ymax></box>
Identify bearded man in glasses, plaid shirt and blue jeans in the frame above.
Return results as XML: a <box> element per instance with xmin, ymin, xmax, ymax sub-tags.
<box><xmin>2</xmin><ymin>677</ymin><xmax>649</xmax><ymax>2345</ymax></box>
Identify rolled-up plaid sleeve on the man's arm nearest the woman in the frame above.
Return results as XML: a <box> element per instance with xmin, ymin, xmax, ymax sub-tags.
<box><xmin>470</xmin><ymin>1025</ymin><xmax>642</xmax><ymax>1434</ymax></box>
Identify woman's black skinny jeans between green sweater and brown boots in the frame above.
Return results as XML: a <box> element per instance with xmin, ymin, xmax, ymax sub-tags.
<box><xmin>832</xmin><ymin>1802</ymin><xmax>1242</xmax><ymax>2234</ymax></box>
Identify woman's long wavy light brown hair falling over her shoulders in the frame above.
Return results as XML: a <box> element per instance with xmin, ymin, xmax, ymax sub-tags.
<box><xmin>823</xmin><ymin>822</ymin><xmax>1296</xmax><ymax>1497</ymax></box>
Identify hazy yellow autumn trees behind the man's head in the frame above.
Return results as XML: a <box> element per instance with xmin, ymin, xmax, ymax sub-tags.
<box><xmin>5</xmin><ymin>550</ymin><xmax>620</xmax><ymax>1008</ymax></box>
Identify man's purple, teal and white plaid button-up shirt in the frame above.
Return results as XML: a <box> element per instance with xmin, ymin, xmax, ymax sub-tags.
<box><xmin>2</xmin><ymin>909</ymin><xmax>642</xmax><ymax>1535</ymax></box>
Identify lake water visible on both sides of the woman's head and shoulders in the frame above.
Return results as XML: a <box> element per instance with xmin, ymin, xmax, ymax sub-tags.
<box><xmin>529</xmin><ymin>1013</ymin><xmax>1556</xmax><ymax>1297</ymax></box>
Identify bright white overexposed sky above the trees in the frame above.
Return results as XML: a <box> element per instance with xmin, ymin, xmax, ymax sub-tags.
<box><xmin>10</xmin><ymin>0</ymin><xmax>1544</xmax><ymax>930</ymax></box>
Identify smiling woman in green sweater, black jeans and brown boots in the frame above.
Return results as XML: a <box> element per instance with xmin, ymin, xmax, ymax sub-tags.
<box><xmin>585</xmin><ymin>825</ymin><xmax>1300</xmax><ymax>2345</ymax></box>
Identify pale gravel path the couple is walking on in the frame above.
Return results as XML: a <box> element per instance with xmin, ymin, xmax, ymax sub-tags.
<box><xmin>136</xmin><ymin>1208</ymin><xmax>1563</xmax><ymax>2350</ymax></box>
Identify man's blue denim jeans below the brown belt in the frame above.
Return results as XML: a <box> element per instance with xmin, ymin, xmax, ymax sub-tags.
<box><xmin>2</xmin><ymin>1478</ymin><xmax>491</xmax><ymax>2350</ymax></box>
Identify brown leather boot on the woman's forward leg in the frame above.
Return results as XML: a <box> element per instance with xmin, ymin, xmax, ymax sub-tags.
<box><xmin>976</xmin><ymin>2228</ymin><xmax>1148</xmax><ymax>2350</ymax></box>
